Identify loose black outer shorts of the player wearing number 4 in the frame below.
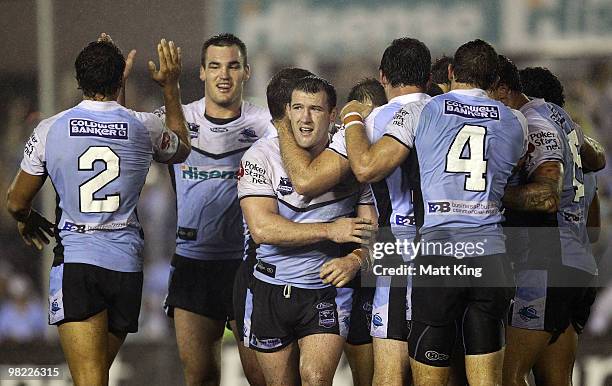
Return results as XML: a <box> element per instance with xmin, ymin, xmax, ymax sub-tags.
<box><xmin>412</xmin><ymin>254</ymin><xmax>514</xmax><ymax>326</ymax></box>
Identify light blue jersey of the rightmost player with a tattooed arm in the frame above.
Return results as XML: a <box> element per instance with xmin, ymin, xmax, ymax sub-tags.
<box><xmin>521</xmin><ymin>99</ymin><xmax>597</xmax><ymax>275</ymax></box>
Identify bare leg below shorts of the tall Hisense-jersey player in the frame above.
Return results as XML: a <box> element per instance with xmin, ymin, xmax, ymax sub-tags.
<box><xmin>174</xmin><ymin>308</ymin><xmax>225</xmax><ymax>386</ymax></box>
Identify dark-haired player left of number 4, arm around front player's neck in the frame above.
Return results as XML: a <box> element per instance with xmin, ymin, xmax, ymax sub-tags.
<box><xmin>279</xmin><ymin>38</ymin><xmax>431</xmax><ymax>385</ymax></box>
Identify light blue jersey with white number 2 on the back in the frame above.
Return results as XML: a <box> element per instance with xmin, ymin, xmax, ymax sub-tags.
<box><xmin>21</xmin><ymin>101</ymin><xmax>178</xmax><ymax>272</ymax></box>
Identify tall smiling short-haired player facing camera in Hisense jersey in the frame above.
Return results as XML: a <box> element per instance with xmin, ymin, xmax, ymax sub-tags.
<box><xmin>157</xmin><ymin>34</ymin><xmax>274</xmax><ymax>385</ymax></box>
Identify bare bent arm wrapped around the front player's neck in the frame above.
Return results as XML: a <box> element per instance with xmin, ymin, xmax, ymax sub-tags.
<box><xmin>275</xmin><ymin>118</ymin><xmax>350</xmax><ymax>197</ymax></box>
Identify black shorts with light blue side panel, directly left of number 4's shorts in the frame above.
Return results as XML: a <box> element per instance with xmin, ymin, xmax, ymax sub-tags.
<box><xmin>370</xmin><ymin>276</ymin><xmax>410</xmax><ymax>342</ymax></box>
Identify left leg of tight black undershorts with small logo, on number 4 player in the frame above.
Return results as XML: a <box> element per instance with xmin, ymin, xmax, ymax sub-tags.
<box><xmin>408</xmin><ymin>321</ymin><xmax>457</xmax><ymax>367</ymax></box>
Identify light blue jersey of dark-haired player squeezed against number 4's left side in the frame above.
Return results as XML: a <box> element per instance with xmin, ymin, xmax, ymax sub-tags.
<box><xmin>329</xmin><ymin>93</ymin><xmax>431</xmax><ymax>241</ymax></box>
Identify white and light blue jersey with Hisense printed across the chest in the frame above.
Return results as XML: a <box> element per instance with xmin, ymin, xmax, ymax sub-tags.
<box><xmin>156</xmin><ymin>99</ymin><xmax>276</xmax><ymax>260</ymax></box>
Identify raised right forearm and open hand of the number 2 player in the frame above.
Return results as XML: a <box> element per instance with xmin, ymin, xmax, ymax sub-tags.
<box><xmin>148</xmin><ymin>39</ymin><xmax>191</xmax><ymax>164</ymax></box>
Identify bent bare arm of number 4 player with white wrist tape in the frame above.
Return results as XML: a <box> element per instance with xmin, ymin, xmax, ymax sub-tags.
<box><xmin>340</xmin><ymin>101</ymin><xmax>410</xmax><ymax>183</ymax></box>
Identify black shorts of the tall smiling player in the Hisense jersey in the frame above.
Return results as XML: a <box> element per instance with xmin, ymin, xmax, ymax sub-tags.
<box><xmin>164</xmin><ymin>254</ymin><xmax>242</xmax><ymax>322</ymax></box>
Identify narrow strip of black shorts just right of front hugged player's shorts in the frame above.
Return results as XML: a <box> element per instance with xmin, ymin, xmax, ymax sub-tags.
<box><xmin>346</xmin><ymin>286</ymin><xmax>375</xmax><ymax>345</ymax></box>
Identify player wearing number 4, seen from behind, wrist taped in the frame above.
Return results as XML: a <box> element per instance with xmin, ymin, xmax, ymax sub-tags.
<box><xmin>341</xmin><ymin>40</ymin><xmax>526</xmax><ymax>385</ymax></box>
